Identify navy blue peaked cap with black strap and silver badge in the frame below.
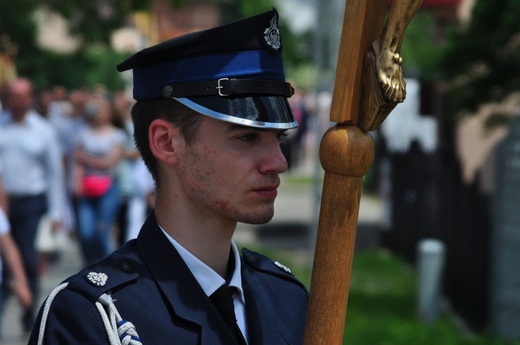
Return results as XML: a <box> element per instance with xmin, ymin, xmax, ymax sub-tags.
<box><xmin>117</xmin><ymin>9</ymin><xmax>298</xmax><ymax>129</ymax></box>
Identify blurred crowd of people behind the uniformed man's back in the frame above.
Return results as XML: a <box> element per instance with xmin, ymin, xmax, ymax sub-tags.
<box><xmin>0</xmin><ymin>78</ymin><xmax>154</xmax><ymax>332</ymax></box>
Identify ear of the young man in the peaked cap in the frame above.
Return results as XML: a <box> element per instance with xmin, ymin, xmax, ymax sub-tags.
<box><xmin>148</xmin><ymin>119</ymin><xmax>180</xmax><ymax>164</ymax></box>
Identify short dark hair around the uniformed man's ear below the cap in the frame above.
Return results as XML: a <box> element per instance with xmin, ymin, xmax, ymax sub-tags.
<box><xmin>132</xmin><ymin>98</ymin><xmax>203</xmax><ymax>185</ymax></box>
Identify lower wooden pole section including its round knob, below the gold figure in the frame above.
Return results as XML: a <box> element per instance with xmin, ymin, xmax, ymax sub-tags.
<box><xmin>304</xmin><ymin>124</ymin><xmax>374</xmax><ymax>345</ymax></box>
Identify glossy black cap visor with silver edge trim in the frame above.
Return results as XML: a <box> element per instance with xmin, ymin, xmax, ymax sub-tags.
<box><xmin>176</xmin><ymin>96</ymin><xmax>298</xmax><ymax>129</ymax></box>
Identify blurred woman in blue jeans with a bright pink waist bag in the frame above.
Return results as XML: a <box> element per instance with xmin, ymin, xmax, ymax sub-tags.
<box><xmin>74</xmin><ymin>95</ymin><xmax>126</xmax><ymax>264</ymax></box>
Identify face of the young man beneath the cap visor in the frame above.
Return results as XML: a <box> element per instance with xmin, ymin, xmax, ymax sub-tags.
<box><xmin>180</xmin><ymin>117</ymin><xmax>287</xmax><ymax>224</ymax></box>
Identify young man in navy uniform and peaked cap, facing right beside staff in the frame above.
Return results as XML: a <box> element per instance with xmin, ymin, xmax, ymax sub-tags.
<box><xmin>29</xmin><ymin>10</ymin><xmax>308</xmax><ymax>345</ymax></box>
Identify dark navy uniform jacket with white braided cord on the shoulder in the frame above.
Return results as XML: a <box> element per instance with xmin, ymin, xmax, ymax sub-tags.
<box><xmin>29</xmin><ymin>215</ymin><xmax>308</xmax><ymax>345</ymax></box>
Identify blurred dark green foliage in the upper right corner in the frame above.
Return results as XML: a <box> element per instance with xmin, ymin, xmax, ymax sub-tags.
<box><xmin>441</xmin><ymin>0</ymin><xmax>520</xmax><ymax>117</ymax></box>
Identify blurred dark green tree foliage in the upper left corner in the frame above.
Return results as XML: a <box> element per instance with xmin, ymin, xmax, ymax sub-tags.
<box><xmin>0</xmin><ymin>0</ymin><xmax>149</xmax><ymax>89</ymax></box>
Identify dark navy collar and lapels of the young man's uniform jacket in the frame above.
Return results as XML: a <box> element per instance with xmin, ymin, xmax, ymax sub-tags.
<box><xmin>137</xmin><ymin>212</ymin><xmax>291</xmax><ymax>345</ymax></box>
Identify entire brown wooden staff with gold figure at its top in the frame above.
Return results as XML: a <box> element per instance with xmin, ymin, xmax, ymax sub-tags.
<box><xmin>304</xmin><ymin>0</ymin><xmax>422</xmax><ymax>345</ymax></box>
